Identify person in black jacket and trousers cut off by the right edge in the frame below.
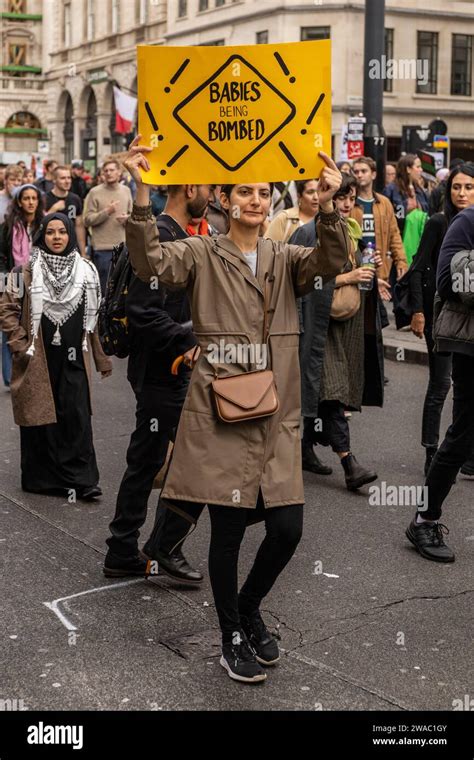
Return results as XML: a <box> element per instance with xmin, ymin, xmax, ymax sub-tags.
<box><xmin>406</xmin><ymin>206</ymin><xmax>474</xmax><ymax>562</ymax></box>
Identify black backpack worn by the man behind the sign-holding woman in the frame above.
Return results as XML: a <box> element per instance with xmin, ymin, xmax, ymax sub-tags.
<box><xmin>98</xmin><ymin>218</ymin><xmax>177</xmax><ymax>359</ymax></box>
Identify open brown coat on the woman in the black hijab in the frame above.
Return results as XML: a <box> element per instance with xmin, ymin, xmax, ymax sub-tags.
<box><xmin>0</xmin><ymin>265</ymin><xmax>112</xmax><ymax>427</ymax></box>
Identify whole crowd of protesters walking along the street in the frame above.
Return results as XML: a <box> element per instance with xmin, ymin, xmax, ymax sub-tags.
<box><xmin>0</xmin><ymin>145</ymin><xmax>474</xmax><ymax>683</ymax></box>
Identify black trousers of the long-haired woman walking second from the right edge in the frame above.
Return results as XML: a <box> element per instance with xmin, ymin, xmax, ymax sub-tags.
<box><xmin>421</xmin><ymin>324</ymin><xmax>452</xmax><ymax>448</ymax></box>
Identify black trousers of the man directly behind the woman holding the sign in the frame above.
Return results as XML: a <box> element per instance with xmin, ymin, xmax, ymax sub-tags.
<box><xmin>107</xmin><ymin>377</ymin><xmax>194</xmax><ymax>557</ymax></box>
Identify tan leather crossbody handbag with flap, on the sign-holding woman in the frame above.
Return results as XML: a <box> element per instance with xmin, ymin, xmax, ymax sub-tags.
<box><xmin>212</xmin><ymin>258</ymin><xmax>280</xmax><ymax>422</ymax></box>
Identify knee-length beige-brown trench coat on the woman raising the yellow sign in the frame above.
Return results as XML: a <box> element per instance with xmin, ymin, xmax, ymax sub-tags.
<box><xmin>126</xmin><ymin>206</ymin><xmax>350</xmax><ymax>508</ymax></box>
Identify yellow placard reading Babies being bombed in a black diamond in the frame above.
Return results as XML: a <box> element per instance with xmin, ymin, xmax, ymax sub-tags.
<box><xmin>138</xmin><ymin>40</ymin><xmax>331</xmax><ymax>185</ymax></box>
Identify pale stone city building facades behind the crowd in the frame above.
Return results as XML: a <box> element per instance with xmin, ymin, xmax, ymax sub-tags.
<box><xmin>0</xmin><ymin>0</ymin><xmax>474</xmax><ymax>169</ymax></box>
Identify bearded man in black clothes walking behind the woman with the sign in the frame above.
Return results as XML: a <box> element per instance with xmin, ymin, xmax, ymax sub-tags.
<box><xmin>104</xmin><ymin>185</ymin><xmax>210</xmax><ymax>585</ymax></box>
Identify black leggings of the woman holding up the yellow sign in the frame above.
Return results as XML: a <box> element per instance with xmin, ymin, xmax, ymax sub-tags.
<box><xmin>209</xmin><ymin>496</ymin><xmax>303</xmax><ymax>642</ymax></box>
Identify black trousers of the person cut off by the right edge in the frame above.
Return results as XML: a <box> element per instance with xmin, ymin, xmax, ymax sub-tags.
<box><xmin>418</xmin><ymin>354</ymin><xmax>474</xmax><ymax>520</ymax></box>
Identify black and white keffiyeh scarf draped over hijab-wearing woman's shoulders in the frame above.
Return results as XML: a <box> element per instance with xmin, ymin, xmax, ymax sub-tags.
<box><xmin>26</xmin><ymin>247</ymin><xmax>101</xmax><ymax>356</ymax></box>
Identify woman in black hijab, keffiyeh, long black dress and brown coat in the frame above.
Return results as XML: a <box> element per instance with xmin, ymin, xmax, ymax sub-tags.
<box><xmin>0</xmin><ymin>213</ymin><xmax>112</xmax><ymax>501</ymax></box>
